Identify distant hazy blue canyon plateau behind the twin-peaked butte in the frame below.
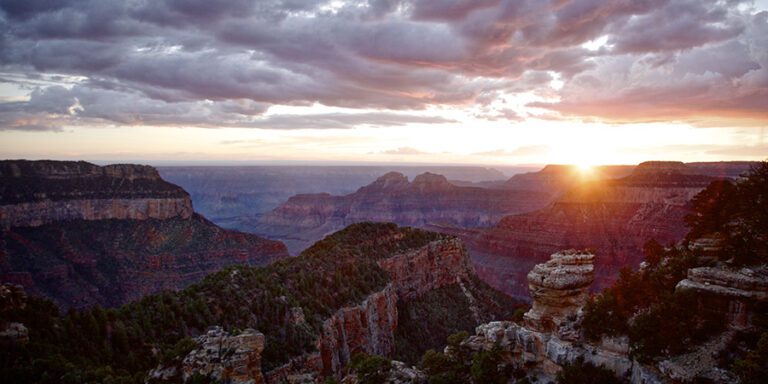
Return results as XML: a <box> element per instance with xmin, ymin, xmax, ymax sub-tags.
<box><xmin>157</xmin><ymin>165</ymin><xmax>520</xmax><ymax>231</ymax></box>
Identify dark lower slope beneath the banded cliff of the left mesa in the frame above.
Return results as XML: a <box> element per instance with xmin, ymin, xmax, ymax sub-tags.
<box><xmin>0</xmin><ymin>214</ymin><xmax>287</xmax><ymax>308</ymax></box>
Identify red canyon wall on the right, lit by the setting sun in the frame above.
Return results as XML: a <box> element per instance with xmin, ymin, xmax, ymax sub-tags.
<box><xmin>468</xmin><ymin>162</ymin><xmax>728</xmax><ymax>297</ymax></box>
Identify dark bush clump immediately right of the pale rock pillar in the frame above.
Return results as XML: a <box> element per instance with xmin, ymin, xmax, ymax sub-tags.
<box><xmin>582</xmin><ymin>243</ymin><xmax>724</xmax><ymax>361</ymax></box>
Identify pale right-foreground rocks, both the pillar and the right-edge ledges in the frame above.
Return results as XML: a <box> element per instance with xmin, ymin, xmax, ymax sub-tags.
<box><xmin>446</xmin><ymin>246</ymin><xmax>768</xmax><ymax>384</ymax></box>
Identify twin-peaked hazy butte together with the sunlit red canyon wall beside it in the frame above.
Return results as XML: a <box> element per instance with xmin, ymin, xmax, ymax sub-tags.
<box><xmin>244</xmin><ymin>161</ymin><xmax>755</xmax><ymax>299</ymax></box>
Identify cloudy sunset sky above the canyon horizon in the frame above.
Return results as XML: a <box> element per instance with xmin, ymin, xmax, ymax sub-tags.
<box><xmin>0</xmin><ymin>0</ymin><xmax>768</xmax><ymax>165</ymax></box>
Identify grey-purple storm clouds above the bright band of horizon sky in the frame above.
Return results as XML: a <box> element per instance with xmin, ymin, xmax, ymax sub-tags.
<box><xmin>0</xmin><ymin>0</ymin><xmax>768</xmax><ymax>129</ymax></box>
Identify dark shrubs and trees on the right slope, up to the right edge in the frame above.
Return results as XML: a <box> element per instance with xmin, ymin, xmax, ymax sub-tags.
<box><xmin>582</xmin><ymin>162</ymin><xmax>768</xmax><ymax>364</ymax></box>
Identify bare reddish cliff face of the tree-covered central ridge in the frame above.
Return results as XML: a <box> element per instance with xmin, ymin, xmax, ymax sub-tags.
<box><xmin>266</xmin><ymin>238</ymin><xmax>474</xmax><ymax>383</ymax></box>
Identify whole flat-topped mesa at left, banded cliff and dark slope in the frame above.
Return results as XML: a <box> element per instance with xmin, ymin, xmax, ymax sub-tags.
<box><xmin>0</xmin><ymin>160</ymin><xmax>287</xmax><ymax>307</ymax></box>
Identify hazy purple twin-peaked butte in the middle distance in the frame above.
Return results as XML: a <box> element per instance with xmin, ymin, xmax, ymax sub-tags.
<box><xmin>254</xmin><ymin>172</ymin><xmax>551</xmax><ymax>252</ymax></box>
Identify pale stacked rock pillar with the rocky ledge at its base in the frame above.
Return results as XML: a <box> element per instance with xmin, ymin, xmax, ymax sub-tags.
<box><xmin>456</xmin><ymin>251</ymin><xmax>663</xmax><ymax>384</ymax></box>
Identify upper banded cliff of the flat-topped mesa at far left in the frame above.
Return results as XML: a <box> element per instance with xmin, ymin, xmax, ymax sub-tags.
<box><xmin>0</xmin><ymin>160</ymin><xmax>194</xmax><ymax>228</ymax></box>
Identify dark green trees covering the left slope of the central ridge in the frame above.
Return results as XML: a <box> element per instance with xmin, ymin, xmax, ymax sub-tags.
<box><xmin>0</xmin><ymin>223</ymin><xmax>444</xmax><ymax>383</ymax></box>
